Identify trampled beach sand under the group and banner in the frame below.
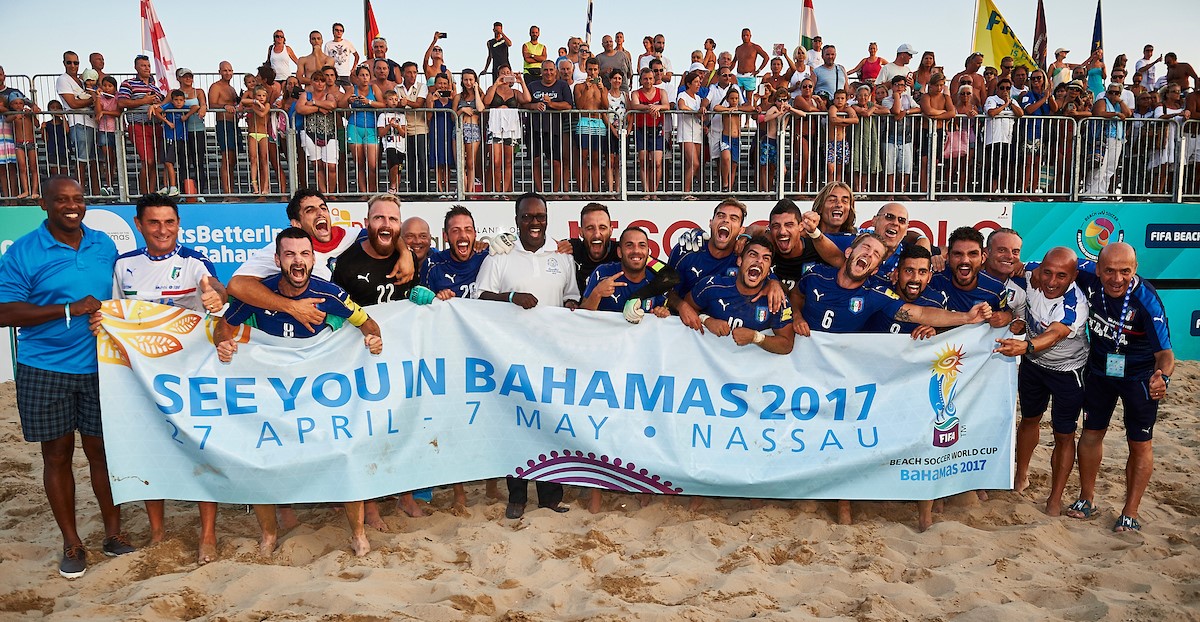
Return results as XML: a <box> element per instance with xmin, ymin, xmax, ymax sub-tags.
<box><xmin>0</xmin><ymin>361</ymin><xmax>1200</xmax><ymax>622</ymax></box>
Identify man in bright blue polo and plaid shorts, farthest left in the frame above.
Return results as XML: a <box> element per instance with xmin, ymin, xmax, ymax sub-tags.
<box><xmin>0</xmin><ymin>177</ymin><xmax>133</xmax><ymax>579</ymax></box>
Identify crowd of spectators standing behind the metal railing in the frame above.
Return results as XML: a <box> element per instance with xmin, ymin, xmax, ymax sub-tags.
<box><xmin>0</xmin><ymin>22</ymin><xmax>1200</xmax><ymax>199</ymax></box>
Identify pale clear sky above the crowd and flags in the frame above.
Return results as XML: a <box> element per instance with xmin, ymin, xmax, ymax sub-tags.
<box><xmin>0</xmin><ymin>0</ymin><xmax>1200</xmax><ymax>86</ymax></box>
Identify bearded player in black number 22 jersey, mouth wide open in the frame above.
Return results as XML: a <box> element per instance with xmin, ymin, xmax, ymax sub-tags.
<box><xmin>334</xmin><ymin>195</ymin><xmax>433</xmax><ymax>531</ymax></box>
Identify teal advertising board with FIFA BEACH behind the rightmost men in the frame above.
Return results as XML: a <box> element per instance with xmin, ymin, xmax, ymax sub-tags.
<box><xmin>1013</xmin><ymin>203</ymin><xmax>1200</xmax><ymax>359</ymax></box>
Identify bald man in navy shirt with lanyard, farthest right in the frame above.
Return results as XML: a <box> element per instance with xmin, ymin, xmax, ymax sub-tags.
<box><xmin>1067</xmin><ymin>243</ymin><xmax>1175</xmax><ymax>532</ymax></box>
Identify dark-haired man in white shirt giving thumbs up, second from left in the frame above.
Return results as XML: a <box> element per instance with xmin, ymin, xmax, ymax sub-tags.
<box><xmin>111</xmin><ymin>193</ymin><xmax>227</xmax><ymax>566</ymax></box>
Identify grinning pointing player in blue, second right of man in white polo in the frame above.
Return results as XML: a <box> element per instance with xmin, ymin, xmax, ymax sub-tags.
<box><xmin>580</xmin><ymin>227</ymin><xmax>671</xmax><ymax>324</ymax></box>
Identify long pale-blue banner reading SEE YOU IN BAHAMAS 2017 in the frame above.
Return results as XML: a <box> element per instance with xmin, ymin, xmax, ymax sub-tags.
<box><xmin>98</xmin><ymin>299</ymin><xmax>1015</xmax><ymax>503</ymax></box>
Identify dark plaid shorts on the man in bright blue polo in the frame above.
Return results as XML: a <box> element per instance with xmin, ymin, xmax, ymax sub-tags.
<box><xmin>17</xmin><ymin>363</ymin><xmax>103</xmax><ymax>443</ymax></box>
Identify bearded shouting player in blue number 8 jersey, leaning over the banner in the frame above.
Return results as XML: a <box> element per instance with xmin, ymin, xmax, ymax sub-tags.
<box><xmin>212</xmin><ymin>227</ymin><xmax>383</xmax><ymax>557</ymax></box>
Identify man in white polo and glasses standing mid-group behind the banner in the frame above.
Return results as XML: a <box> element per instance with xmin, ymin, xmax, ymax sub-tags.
<box><xmin>476</xmin><ymin>192</ymin><xmax>580</xmax><ymax>519</ymax></box>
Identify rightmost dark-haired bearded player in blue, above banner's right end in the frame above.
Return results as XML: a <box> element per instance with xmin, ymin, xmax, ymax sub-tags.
<box><xmin>929</xmin><ymin>227</ymin><xmax>1013</xmax><ymax>328</ymax></box>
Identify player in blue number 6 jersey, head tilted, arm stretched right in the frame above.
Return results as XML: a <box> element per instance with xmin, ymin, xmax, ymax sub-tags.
<box><xmin>792</xmin><ymin>233</ymin><xmax>991</xmax><ymax>525</ymax></box>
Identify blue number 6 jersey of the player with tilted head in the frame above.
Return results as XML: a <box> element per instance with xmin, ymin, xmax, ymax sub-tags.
<box><xmin>800</xmin><ymin>265</ymin><xmax>905</xmax><ymax>333</ymax></box>
